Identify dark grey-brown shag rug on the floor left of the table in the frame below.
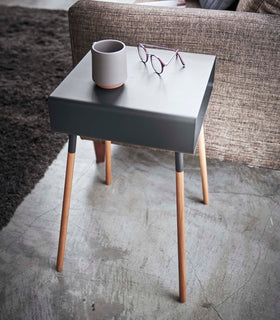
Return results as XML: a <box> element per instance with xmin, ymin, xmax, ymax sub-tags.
<box><xmin>0</xmin><ymin>6</ymin><xmax>72</xmax><ymax>230</ymax></box>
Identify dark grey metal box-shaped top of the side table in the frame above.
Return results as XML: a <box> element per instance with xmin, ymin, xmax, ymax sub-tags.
<box><xmin>49</xmin><ymin>47</ymin><xmax>216</xmax><ymax>153</ymax></box>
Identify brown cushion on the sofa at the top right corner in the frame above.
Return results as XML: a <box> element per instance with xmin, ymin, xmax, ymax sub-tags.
<box><xmin>236</xmin><ymin>0</ymin><xmax>280</xmax><ymax>14</ymax></box>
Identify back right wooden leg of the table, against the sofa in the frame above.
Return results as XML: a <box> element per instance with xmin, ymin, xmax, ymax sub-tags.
<box><xmin>198</xmin><ymin>126</ymin><xmax>209</xmax><ymax>204</ymax></box>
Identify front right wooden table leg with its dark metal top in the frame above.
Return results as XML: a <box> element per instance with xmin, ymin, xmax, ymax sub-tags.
<box><xmin>175</xmin><ymin>152</ymin><xmax>187</xmax><ymax>302</ymax></box>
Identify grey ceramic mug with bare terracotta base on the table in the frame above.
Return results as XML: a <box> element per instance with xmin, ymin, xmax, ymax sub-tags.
<box><xmin>91</xmin><ymin>39</ymin><xmax>127</xmax><ymax>89</ymax></box>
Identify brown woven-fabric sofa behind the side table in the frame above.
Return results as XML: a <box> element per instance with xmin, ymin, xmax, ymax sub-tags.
<box><xmin>69</xmin><ymin>0</ymin><xmax>280</xmax><ymax>169</ymax></box>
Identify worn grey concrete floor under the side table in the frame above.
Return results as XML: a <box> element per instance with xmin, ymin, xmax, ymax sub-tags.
<box><xmin>0</xmin><ymin>140</ymin><xmax>280</xmax><ymax>320</ymax></box>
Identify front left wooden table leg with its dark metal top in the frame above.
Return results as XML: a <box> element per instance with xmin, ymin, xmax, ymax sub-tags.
<box><xmin>56</xmin><ymin>135</ymin><xmax>77</xmax><ymax>271</ymax></box>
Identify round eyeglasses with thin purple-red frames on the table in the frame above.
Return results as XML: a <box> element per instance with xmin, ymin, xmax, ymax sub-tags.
<box><xmin>137</xmin><ymin>43</ymin><xmax>185</xmax><ymax>74</ymax></box>
